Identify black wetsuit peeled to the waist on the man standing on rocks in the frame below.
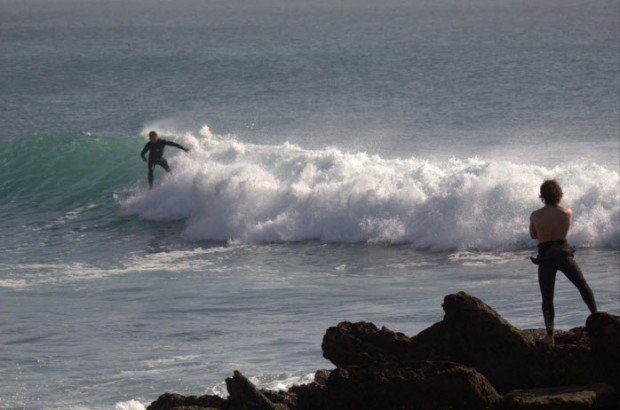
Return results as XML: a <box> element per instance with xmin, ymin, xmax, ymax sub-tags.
<box><xmin>532</xmin><ymin>240</ymin><xmax>596</xmax><ymax>334</ymax></box>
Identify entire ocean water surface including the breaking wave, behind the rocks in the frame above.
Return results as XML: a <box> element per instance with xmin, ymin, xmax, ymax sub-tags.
<box><xmin>0</xmin><ymin>0</ymin><xmax>620</xmax><ymax>409</ymax></box>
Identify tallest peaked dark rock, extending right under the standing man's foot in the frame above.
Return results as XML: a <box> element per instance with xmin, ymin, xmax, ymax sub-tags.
<box><xmin>412</xmin><ymin>292</ymin><xmax>593</xmax><ymax>392</ymax></box>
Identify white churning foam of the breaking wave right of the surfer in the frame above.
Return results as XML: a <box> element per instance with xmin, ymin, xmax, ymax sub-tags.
<box><xmin>118</xmin><ymin>127</ymin><xmax>620</xmax><ymax>250</ymax></box>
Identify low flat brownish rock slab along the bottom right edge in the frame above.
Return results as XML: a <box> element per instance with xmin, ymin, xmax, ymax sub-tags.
<box><xmin>500</xmin><ymin>383</ymin><xmax>618</xmax><ymax>410</ymax></box>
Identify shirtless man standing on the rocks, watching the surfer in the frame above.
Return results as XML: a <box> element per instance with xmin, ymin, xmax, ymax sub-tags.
<box><xmin>530</xmin><ymin>179</ymin><xmax>596</xmax><ymax>344</ymax></box>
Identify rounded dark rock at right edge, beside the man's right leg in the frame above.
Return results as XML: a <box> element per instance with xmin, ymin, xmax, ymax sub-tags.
<box><xmin>586</xmin><ymin>312</ymin><xmax>620</xmax><ymax>391</ymax></box>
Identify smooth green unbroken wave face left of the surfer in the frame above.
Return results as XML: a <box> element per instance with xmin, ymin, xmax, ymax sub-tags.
<box><xmin>0</xmin><ymin>133</ymin><xmax>144</xmax><ymax>210</ymax></box>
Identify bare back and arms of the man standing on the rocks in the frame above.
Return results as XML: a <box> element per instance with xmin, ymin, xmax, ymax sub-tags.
<box><xmin>530</xmin><ymin>205</ymin><xmax>573</xmax><ymax>243</ymax></box>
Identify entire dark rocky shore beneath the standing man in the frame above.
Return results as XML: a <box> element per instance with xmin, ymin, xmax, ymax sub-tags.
<box><xmin>148</xmin><ymin>292</ymin><xmax>620</xmax><ymax>410</ymax></box>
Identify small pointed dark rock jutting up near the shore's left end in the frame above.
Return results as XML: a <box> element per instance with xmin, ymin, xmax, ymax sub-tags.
<box><xmin>226</xmin><ymin>370</ymin><xmax>288</xmax><ymax>410</ymax></box>
